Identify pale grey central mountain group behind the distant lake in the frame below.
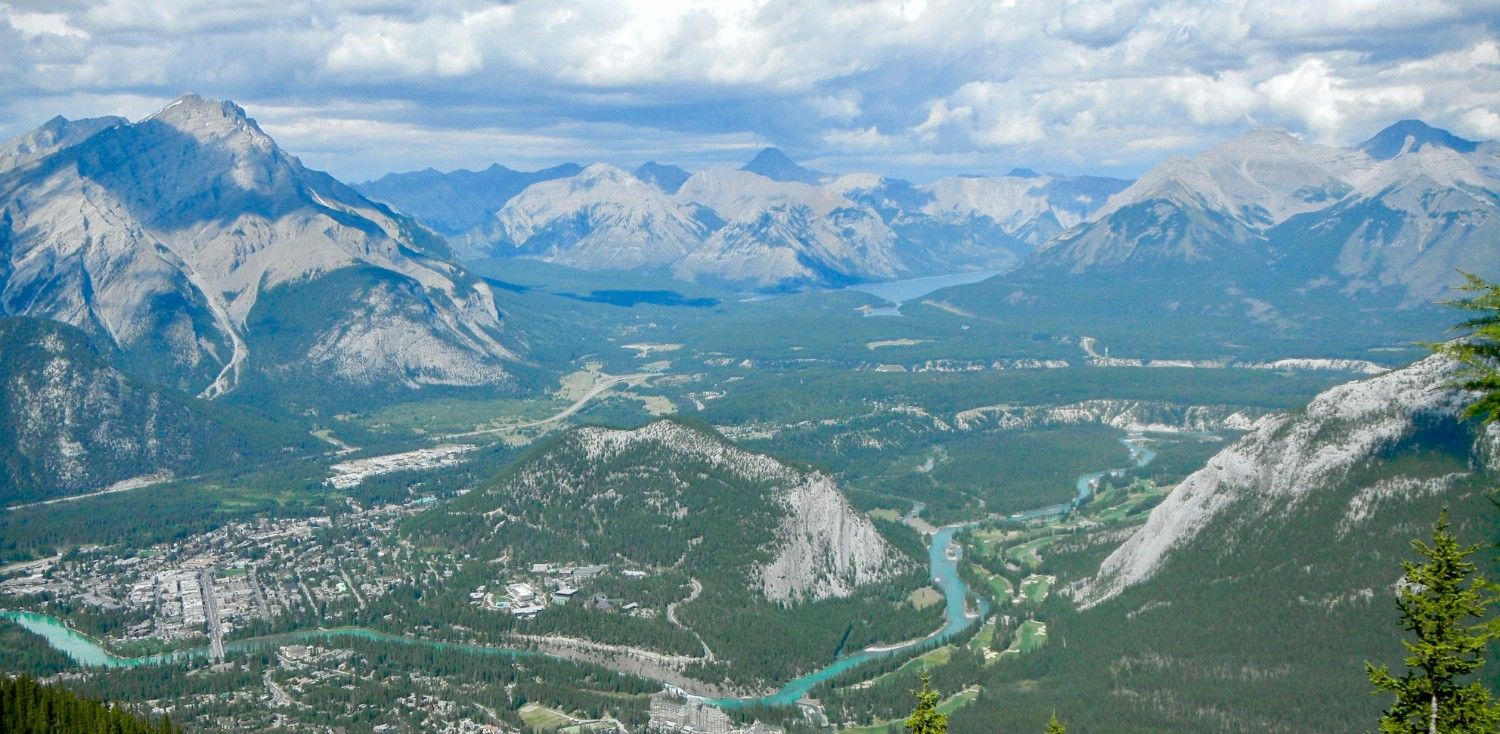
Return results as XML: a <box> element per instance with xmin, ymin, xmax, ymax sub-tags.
<box><xmin>459</xmin><ymin>149</ymin><xmax>1127</xmax><ymax>290</ymax></box>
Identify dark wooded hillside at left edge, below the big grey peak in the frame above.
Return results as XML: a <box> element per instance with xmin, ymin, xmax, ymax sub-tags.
<box><xmin>0</xmin><ymin>318</ymin><xmax>308</xmax><ymax>504</ymax></box>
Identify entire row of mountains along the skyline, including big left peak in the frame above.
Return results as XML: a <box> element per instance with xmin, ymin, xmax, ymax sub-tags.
<box><xmin>0</xmin><ymin>95</ymin><xmax>1500</xmax><ymax>398</ymax></box>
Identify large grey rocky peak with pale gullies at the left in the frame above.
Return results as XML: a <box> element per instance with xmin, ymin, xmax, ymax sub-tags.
<box><xmin>0</xmin><ymin>95</ymin><xmax>522</xmax><ymax>398</ymax></box>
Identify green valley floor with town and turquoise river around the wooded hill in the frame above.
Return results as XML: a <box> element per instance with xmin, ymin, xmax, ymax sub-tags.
<box><xmin>0</xmin><ymin>259</ymin><xmax>1367</xmax><ymax>723</ymax></box>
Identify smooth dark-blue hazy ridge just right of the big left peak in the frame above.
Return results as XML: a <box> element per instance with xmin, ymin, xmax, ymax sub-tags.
<box><xmin>354</xmin><ymin>164</ymin><xmax>584</xmax><ymax>236</ymax></box>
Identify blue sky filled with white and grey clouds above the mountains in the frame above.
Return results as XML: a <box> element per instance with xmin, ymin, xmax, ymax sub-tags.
<box><xmin>0</xmin><ymin>0</ymin><xmax>1500</xmax><ymax>180</ymax></box>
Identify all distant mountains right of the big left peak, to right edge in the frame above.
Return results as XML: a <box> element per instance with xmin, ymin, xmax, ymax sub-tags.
<box><xmin>354</xmin><ymin>120</ymin><xmax>1500</xmax><ymax>306</ymax></box>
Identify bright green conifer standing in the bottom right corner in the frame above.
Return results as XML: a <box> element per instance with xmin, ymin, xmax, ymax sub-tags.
<box><xmin>1365</xmin><ymin>507</ymin><xmax>1500</xmax><ymax>734</ymax></box>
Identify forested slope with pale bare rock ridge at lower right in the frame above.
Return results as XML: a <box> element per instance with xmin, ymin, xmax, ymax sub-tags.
<box><xmin>951</xmin><ymin>351</ymin><xmax>1500</xmax><ymax>734</ymax></box>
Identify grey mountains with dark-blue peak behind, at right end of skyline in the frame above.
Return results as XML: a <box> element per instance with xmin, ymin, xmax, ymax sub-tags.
<box><xmin>950</xmin><ymin>120</ymin><xmax>1500</xmax><ymax>327</ymax></box>
